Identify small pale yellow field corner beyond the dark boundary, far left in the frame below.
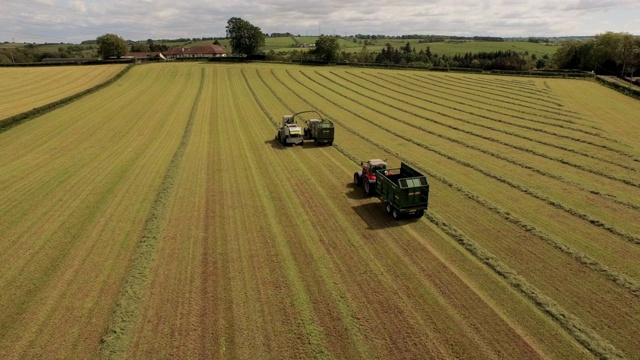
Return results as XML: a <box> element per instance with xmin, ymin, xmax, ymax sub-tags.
<box><xmin>0</xmin><ymin>65</ymin><xmax>126</xmax><ymax>120</ymax></box>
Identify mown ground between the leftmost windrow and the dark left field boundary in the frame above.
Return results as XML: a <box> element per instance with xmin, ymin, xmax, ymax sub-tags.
<box><xmin>0</xmin><ymin>63</ymin><xmax>197</xmax><ymax>359</ymax></box>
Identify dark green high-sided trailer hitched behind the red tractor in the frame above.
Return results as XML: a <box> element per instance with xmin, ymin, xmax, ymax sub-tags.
<box><xmin>364</xmin><ymin>163</ymin><xmax>429</xmax><ymax>219</ymax></box>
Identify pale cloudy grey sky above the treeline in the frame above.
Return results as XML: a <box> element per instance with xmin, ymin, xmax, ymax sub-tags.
<box><xmin>0</xmin><ymin>0</ymin><xmax>640</xmax><ymax>44</ymax></box>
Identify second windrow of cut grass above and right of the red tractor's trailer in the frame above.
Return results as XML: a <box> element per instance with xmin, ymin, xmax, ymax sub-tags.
<box><xmin>296</xmin><ymin>69</ymin><xmax>640</xmax><ymax>244</ymax></box>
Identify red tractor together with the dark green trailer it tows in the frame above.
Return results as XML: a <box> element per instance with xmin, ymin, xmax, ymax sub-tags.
<box><xmin>353</xmin><ymin>159</ymin><xmax>429</xmax><ymax>219</ymax></box>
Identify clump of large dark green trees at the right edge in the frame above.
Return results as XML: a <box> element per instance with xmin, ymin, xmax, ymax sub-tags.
<box><xmin>553</xmin><ymin>32</ymin><xmax>640</xmax><ymax>77</ymax></box>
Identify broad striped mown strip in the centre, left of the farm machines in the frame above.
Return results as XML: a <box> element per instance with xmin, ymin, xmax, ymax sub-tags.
<box><xmin>117</xmin><ymin>65</ymin><xmax>588</xmax><ymax>358</ymax></box>
